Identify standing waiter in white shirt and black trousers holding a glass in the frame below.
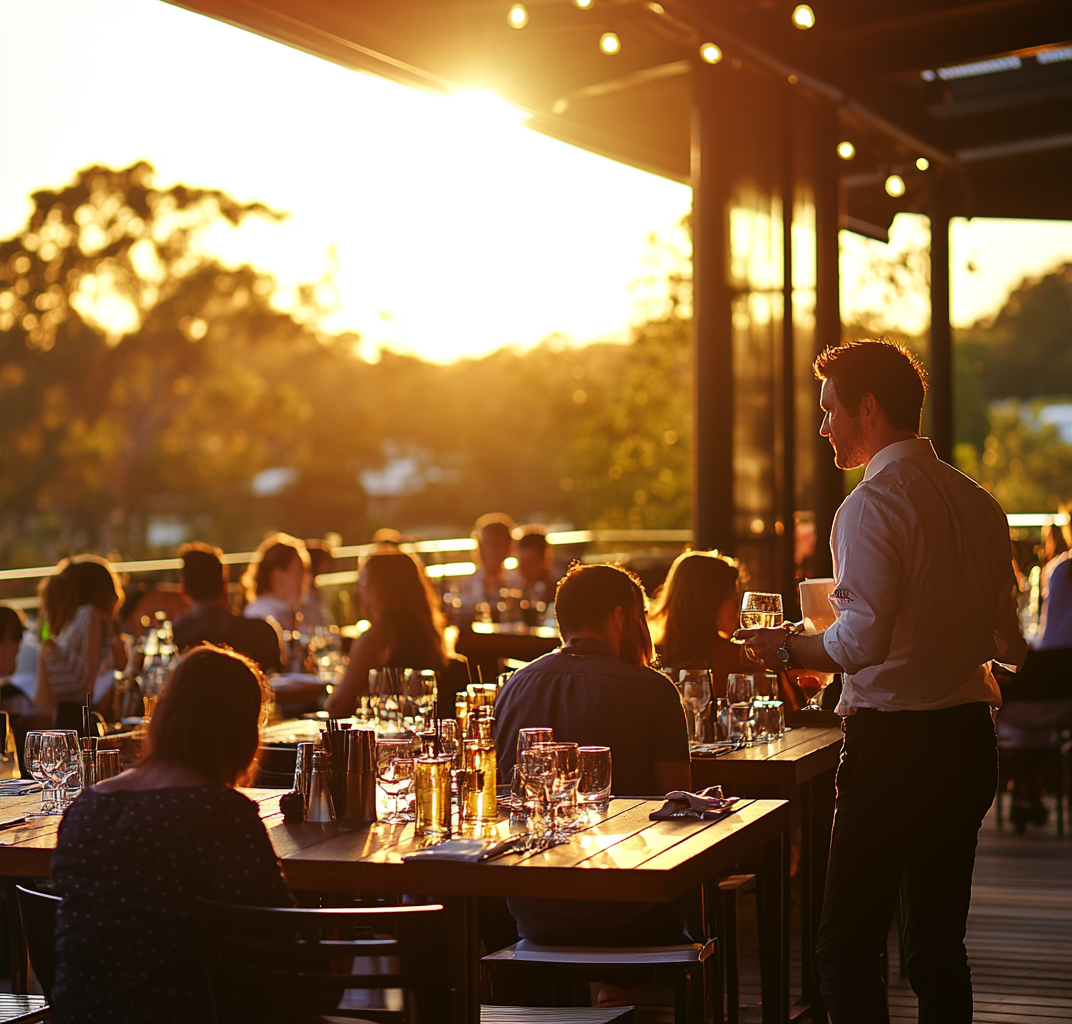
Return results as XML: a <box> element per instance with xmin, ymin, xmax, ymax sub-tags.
<box><xmin>738</xmin><ymin>341</ymin><xmax>1026</xmax><ymax>1024</ymax></box>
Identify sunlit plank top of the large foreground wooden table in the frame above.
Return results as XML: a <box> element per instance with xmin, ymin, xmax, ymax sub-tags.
<box><xmin>0</xmin><ymin>789</ymin><xmax>789</xmax><ymax>902</ymax></box>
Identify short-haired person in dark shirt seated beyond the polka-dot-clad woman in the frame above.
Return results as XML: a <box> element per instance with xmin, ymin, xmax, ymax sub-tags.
<box><xmin>172</xmin><ymin>541</ymin><xmax>286</xmax><ymax>672</ymax></box>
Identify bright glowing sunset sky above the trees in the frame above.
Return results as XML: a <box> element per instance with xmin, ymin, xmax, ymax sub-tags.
<box><xmin>0</xmin><ymin>0</ymin><xmax>1072</xmax><ymax>361</ymax></box>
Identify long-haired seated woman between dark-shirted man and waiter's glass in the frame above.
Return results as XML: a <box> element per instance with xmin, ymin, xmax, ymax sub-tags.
<box><xmin>649</xmin><ymin>551</ymin><xmax>756</xmax><ymax>697</ymax></box>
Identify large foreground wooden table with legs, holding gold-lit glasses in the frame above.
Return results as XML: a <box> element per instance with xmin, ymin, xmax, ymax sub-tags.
<box><xmin>0</xmin><ymin>789</ymin><xmax>790</xmax><ymax>1024</ymax></box>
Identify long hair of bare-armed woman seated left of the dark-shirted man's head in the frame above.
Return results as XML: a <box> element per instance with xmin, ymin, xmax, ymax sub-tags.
<box><xmin>361</xmin><ymin>551</ymin><xmax>445</xmax><ymax>668</ymax></box>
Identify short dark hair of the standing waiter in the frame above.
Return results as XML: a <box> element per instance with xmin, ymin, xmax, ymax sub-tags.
<box><xmin>814</xmin><ymin>339</ymin><xmax>927</xmax><ymax>433</ymax></box>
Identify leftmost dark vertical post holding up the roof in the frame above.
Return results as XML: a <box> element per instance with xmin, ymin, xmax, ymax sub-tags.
<box><xmin>691</xmin><ymin>61</ymin><xmax>734</xmax><ymax>551</ymax></box>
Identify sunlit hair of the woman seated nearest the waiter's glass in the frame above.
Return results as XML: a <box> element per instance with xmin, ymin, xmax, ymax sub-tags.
<box><xmin>649</xmin><ymin>551</ymin><xmax>740</xmax><ymax>667</ymax></box>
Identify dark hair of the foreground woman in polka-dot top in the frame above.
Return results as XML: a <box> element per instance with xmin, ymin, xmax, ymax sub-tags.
<box><xmin>143</xmin><ymin>643</ymin><xmax>268</xmax><ymax>786</ymax></box>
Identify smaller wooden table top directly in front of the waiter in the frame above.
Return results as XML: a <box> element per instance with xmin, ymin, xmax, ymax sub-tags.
<box><xmin>693</xmin><ymin>727</ymin><xmax>842</xmax><ymax>796</ymax></box>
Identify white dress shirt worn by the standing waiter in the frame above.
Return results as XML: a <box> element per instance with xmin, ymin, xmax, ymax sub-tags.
<box><xmin>823</xmin><ymin>437</ymin><xmax>1027</xmax><ymax>715</ymax></box>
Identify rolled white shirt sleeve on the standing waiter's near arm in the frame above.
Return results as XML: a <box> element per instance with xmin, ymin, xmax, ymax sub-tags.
<box><xmin>823</xmin><ymin>495</ymin><xmax>904</xmax><ymax>674</ymax></box>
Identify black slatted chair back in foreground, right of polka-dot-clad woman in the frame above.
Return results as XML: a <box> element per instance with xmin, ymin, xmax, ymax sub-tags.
<box><xmin>197</xmin><ymin>899</ymin><xmax>451</xmax><ymax>1024</ymax></box>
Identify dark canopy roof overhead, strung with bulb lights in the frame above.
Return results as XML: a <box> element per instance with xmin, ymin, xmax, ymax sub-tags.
<box><xmin>171</xmin><ymin>0</ymin><xmax>1072</xmax><ymax>232</ymax></box>
